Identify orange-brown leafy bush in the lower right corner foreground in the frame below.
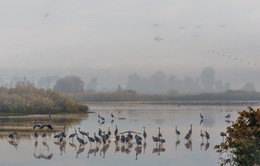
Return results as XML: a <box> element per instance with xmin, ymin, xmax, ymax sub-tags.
<box><xmin>215</xmin><ymin>107</ymin><xmax>260</xmax><ymax>166</ymax></box>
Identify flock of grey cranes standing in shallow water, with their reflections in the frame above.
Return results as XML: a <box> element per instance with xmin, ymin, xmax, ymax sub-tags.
<box><xmin>6</xmin><ymin>113</ymin><xmax>231</xmax><ymax>159</ymax></box>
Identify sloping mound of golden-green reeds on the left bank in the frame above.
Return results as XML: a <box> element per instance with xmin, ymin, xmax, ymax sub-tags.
<box><xmin>0</xmin><ymin>82</ymin><xmax>88</xmax><ymax>114</ymax></box>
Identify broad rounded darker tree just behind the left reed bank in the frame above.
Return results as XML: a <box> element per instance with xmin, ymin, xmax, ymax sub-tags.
<box><xmin>54</xmin><ymin>76</ymin><xmax>85</xmax><ymax>93</ymax></box>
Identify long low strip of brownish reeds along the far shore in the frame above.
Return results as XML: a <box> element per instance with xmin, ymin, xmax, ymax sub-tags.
<box><xmin>74</xmin><ymin>90</ymin><xmax>260</xmax><ymax>102</ymax></box>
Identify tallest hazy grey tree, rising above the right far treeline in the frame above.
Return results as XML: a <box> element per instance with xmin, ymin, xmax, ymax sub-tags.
<box><xmin>200</xmin><ymin>67</ymin><xmax>216</xmax><ymax>92</ymax></box>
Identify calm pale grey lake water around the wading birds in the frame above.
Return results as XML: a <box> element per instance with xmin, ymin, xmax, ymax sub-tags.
<box><xmin>0</xmin><ymin>104</ymin><xmax>256</xmax><ymax>166</ymax></box>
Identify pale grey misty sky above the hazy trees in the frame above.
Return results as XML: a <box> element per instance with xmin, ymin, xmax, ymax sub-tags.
<box><xmin>0</xmin><ymin>0</ymin><xmax>260</xmax><ymax>90</ymax></box>
